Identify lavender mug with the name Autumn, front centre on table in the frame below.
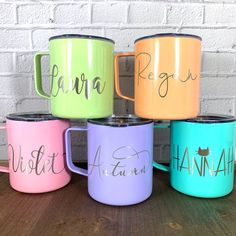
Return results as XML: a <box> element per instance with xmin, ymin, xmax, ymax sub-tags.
<box><xmin>65</xmin><ymin>116</ymin><xmax>153</xmax><ymax>206</ymax></box>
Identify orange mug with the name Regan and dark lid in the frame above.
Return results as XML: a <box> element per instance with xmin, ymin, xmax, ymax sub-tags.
<box><xmin>115</xmin><ymin>34</ymin><xmax>201</xmax><ymax>120</ymax></box>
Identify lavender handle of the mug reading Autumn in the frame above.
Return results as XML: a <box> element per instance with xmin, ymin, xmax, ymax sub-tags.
<box><xmin>65</xmin><ymin>127</ymin><xmax>88</xmax><ymax>176</ymax></box>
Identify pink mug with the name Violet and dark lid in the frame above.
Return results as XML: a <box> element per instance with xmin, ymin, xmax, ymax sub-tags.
<box><xmin>0</xmin><ymin>113</ymin><xmax>71</xmax><ymax>193</ymax></box>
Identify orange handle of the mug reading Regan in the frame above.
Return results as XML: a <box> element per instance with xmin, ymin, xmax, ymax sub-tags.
<box><xmin>114</xmin><ymin>52</ymin><xmax>134</xmax><ymax>102</ymax></box>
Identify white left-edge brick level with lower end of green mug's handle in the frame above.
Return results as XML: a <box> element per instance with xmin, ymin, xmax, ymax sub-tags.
<box><xmin>0</xmin><ymin>76</ymin><xmax>30</xmax><ymax>97</ymax></box>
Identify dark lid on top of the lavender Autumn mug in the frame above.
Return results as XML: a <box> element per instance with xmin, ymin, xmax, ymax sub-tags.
<box><xmin>88</xmin><ymin>115</ymin><xmax>153</xmax><ymax>127</ymax></box>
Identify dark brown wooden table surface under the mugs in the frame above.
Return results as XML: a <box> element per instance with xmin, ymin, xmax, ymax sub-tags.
<box><xmin>0</xmin><ymin>170</ymin><xmax>236</xmax><ymax>236</ymax></box>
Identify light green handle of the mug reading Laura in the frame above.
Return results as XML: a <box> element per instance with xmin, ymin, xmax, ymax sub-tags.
<box><xmin>34</xmin><ymin>52</ymin><xmax>50</xmax><ymax>99</ymax></box>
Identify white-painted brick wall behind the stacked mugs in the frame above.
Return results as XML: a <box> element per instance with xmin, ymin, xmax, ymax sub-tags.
<box><xmin>0</xmin><ymin>0</ymin><xmax>236</xmax><ymax>161</ymax></box>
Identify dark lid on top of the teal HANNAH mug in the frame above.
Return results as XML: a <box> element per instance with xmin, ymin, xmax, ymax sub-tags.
<box><xmin>184</xmin><ymin>114</ymin><xmax>236</xmax><ymax>123</ymax></box>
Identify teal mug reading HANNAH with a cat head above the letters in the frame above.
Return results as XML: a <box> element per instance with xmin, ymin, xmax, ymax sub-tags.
<box><xmin>153</xmin><ymin>115</ymin><xmax>236</xmax><ymax>198</ymax></box>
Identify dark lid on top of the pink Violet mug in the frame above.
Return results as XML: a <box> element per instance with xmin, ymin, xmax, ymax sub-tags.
<box><xmin>6</xmin><ymin>112</ymin><xmax>61</xmax><ymax>121</ymax></box>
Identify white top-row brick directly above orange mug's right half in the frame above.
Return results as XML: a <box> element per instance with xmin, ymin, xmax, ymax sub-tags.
<box><xmin>167</xmin><ymin>4</ymin><xmax>203</xmax><ymax>25</ymax></box>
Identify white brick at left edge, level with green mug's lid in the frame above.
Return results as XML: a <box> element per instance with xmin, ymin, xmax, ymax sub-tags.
<box><xmin>0</xmin><ymin>29</ymin><xmax>30</xmax><ymax>50</ymax></box>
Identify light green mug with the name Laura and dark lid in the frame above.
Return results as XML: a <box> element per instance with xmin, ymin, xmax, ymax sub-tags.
<box><xmin>34</xmin><ymin>34</ymin><xmax>114</xmax><ymax>119</ymax></box>
